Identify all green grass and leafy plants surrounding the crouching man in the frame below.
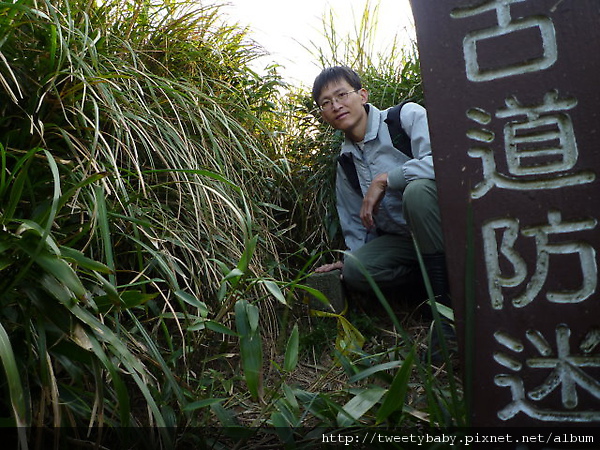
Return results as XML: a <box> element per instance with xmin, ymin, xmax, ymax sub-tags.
<box><xmin>0</xmin><ymin>0</ymin><xmax>463</xmax><ymax>448</ymax></box>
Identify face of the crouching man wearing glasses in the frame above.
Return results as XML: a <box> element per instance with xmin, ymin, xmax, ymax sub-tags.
<box><xmin>318</xmin><ymin>80</ymin><xmax>369</xmax><ymax>133</ymax></box>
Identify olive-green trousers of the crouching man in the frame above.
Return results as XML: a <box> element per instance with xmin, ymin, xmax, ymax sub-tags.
<box><xmin>343</xmin><ymin>180</ymin><xmax>444</xmax><ymax>292</ymax></box>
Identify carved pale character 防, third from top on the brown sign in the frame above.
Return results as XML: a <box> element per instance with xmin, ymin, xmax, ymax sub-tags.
<box><xmin>482</xmin><ymin>211</ymin><xmax>598</xmax><ymax>309</ymax></box>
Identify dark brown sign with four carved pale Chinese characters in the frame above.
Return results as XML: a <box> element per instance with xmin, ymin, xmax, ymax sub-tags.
<box><xmin>412</xmin><ymin>0</ymin><xmax>600</xmax><ymax>426</ymax></box>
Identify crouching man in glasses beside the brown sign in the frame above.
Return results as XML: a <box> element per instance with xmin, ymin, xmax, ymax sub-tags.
<box><xmin>312</xmin><ymin>67</ymin><xmax>450</xmax><ymax>320</ymax></box>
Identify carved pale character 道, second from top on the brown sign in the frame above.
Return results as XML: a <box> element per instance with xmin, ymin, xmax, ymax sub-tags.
<box><xmin>467</xmin><ymin>91</ymin><xmax>596</xmax><ymax>198</ymax></box>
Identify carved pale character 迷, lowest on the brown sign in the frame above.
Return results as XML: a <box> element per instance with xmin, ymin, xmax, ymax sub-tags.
<box><xmin>494</xmin><ymin>324</ymin><xmax>600</xmax><ymax>422</ymax></box>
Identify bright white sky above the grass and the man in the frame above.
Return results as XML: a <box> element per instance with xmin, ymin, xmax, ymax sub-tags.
<box><xmin>215</xmin><ymin>0</ymin><xmax>414</xmax><ymax>86</ymax></box>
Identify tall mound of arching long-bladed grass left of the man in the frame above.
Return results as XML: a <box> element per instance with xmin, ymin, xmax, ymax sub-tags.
<box><xmin>0</xmin><ymin>0</ymin><xmax>289</xmax><ymax>443</ymax></box>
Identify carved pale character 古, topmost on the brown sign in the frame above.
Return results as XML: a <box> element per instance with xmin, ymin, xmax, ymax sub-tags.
<box><xmin>451</xmin><ymin>0</ymin><xmax>558</xmax><ymax>82</ymax></box>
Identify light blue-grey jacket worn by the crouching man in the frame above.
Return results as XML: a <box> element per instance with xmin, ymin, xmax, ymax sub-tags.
<box><xmin>336</xmin><ymin>103</ymin><xmax>435</xmax><ymax>251</ymax></box>
